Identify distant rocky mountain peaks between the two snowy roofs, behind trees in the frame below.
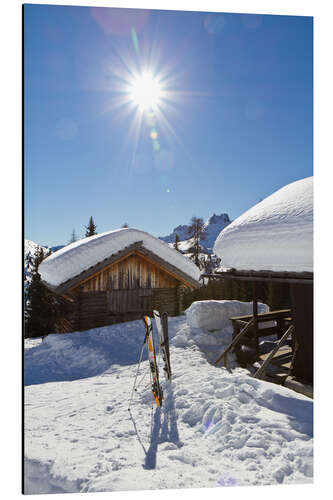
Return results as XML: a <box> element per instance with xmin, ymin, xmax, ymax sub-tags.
<box><xmin>159</xmin><ymin>214</ymin><xmax>231</xmax><ymax>254</ymax></box>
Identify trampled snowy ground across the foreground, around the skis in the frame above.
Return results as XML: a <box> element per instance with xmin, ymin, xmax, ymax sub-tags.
<box><xmin>25</xmin><ymin>316</ymin><xmax>313</xmax><ymax>493</ymax></box>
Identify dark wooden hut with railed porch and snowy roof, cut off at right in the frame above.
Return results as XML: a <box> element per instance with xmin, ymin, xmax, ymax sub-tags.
<box><xmin>209</xmin><ymin>177</ymin><xmax>313</xmax><ymax>384</ymax></box>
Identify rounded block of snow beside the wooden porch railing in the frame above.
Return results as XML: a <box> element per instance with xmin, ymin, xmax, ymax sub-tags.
<box><xmin>185</xmin><ymin>300</ymin><xmax>269</xmax><ymax>331</ymax></box>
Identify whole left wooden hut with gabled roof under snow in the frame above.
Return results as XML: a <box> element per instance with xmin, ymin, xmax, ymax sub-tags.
<box><xmin>40</xmin><ymin>228</ymin><xmax>200</xmax><ymax>332</ymax></box>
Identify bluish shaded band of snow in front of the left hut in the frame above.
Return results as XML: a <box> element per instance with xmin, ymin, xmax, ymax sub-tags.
<box><xmin>24</xmin><ymin>320</ymin><xmax>146</xmax><ymax>385</ymax></box>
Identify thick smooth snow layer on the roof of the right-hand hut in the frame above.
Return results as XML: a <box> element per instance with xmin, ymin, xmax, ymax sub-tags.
<box><xmin>214</xmin><ymin>177</ymin><xmax>313</xmax><ymax>272</ymax></box>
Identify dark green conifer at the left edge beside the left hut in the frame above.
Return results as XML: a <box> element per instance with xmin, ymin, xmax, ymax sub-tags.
<box><xmin>24</xmin><ymin>248</ymin><xmax>57</xmax><ymax>337</ymax></box>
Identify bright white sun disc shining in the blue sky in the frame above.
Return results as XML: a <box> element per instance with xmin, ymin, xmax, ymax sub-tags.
<box><xmin>129</xmin><ymin>73</ymin><xmax>162</xmax><ymax>111</ymax></box>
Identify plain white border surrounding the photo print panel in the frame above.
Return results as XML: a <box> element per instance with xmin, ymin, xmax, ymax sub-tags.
<box><xmin>0</xmin><ymin>0</ymin><xmax>333</xmax><ymax>500</ymax></box>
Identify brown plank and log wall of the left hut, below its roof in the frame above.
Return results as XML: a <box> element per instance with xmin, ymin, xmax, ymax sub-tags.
<box><xmin>59</xmin><ymin>253</ymin><xmax>189</xmax><ymax>331</ymax></box>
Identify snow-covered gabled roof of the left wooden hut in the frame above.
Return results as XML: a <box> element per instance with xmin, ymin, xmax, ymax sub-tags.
<box><xmin>39</xmin><ymin>228</ymin><xmax>200</xmax><ymax>288</ymax></box>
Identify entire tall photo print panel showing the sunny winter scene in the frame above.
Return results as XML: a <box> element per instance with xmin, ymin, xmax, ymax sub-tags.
<box><xmin>22</xmin><ymin>2</ymin><xmax>313</xmax><ymax>495</ymax></box>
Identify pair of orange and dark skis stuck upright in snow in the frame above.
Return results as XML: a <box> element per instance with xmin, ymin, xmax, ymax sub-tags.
<box><xmin>143</xmin><ymin>311</ymin><xmax>171</xmax><ymax>406</ymax></box>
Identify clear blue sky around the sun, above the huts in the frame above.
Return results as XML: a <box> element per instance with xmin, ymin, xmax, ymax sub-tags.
<box><xmin>24</xmin><ymin>5</ymin><xmax>313</xmax><ymax>246</ymax></box>
